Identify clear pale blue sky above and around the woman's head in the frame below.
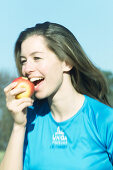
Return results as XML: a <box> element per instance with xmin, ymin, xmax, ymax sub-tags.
<box><xmin>0</xmin><ymin>0</ymin><xmax>113</xmax><ymax>74</ymax></box>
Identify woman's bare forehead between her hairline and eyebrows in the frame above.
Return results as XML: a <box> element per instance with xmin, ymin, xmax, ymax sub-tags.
<box><xmin>21</xmin><ymin>35</ymin><xmax>47</xmax><ymax>55</ymax></box>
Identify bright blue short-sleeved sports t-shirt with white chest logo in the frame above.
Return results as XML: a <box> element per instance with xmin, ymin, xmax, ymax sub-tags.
<box><xmin>23</xmin><ymin>95</ymin><xmax>113</xmax><ymax>170</ymax></box>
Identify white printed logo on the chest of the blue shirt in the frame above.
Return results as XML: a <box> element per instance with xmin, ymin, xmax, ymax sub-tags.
<box><xmin>52</xmin><ymin>126</ymin><xmax>67</xmax><ymax>148</ymax></box>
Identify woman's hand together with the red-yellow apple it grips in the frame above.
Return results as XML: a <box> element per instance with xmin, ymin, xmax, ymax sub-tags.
<box><xmin>4</xmin><ymin>77</ymin><xmax>34</xmax><ymax>127</ymax></box>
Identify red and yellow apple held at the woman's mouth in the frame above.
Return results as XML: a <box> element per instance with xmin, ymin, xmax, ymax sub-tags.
<box><xmin>13</xmin><ymin>77</ymin><xmax>34</xmax><ymax>99</ymax></box>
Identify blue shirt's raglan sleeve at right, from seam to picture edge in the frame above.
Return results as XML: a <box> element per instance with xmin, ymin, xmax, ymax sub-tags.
<box><xmin>84</xmin><ymin>96</ymin><xmax>113</xmax><ymax>164</ymax></box>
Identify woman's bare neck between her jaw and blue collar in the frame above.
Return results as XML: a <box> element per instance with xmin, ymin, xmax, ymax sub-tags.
<box><xmin>48</xmin><ymin>74</ymin><xmax>84</xmax><ymax>122</ymax></box>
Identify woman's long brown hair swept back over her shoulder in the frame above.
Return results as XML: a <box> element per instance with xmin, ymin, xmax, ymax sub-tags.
<box><xmin>15</xmin><ymin>22</ymin><xmax>110</xmax><ymax>105</ymax></box>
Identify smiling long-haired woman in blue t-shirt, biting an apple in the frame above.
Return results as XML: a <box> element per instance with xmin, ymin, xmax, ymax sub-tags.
<box><xmin>0</xmin><ymin>22</ymin><xmax>113</xmax><ymax>170</ymax></box>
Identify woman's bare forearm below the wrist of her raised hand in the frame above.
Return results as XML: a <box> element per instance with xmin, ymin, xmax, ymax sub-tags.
<box><xmin>0</xmin><ymin>124</ymin><xmax>25</xmax><ymax>170</ymax></box>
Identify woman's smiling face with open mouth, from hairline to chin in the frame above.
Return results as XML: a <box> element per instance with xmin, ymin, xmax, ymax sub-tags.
<box><xmin>20</xmin><ymin>35</ymin><xmax>64</xmax><ymax>99</ymax></box>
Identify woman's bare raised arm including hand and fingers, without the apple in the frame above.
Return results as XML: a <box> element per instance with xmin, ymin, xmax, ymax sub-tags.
<box><xmin>0</xmin><ymin>83</ymin><xmax>33</xmax><ymax>170</ymax></box>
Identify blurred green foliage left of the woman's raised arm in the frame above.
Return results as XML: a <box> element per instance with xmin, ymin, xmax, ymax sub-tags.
<box><xmin>0</xmin><ymin>72</ymin><xmax>15</xmax><ymax>150</ymax></box>
